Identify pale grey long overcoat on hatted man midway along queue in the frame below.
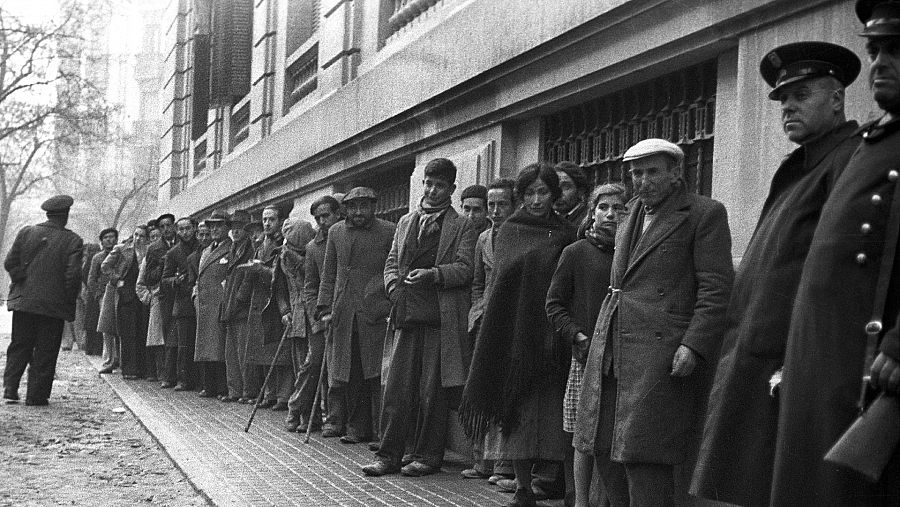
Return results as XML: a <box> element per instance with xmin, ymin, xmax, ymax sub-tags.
<box><xmin>194</xmin><ymin>238</ymin><xmax>231</xmax><ymax>361</ymax></box>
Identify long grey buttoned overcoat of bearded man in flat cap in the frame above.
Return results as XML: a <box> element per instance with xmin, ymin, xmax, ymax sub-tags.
<box><xmin>317</xmin><ymin>218</ymin><xmax>395</xmax><ymax>384</ymax></box>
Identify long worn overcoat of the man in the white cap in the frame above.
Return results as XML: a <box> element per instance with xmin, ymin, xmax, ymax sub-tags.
<box><xmin>573</xmin><ymin>189</ymin><xmax>734</xmax><ymax>465</ymax></box>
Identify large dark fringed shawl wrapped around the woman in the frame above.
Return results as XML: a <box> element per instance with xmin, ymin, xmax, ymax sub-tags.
<box><xmin>459</xmin><ymin>210</ymin><xmax>575</xmax><ymax>441</ymax></box>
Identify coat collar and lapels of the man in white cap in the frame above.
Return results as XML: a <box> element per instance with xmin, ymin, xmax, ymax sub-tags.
<box><xmin>616</xmin><ymin>188</ymin><xmax>691</xmax><ymax>279</ymax></box>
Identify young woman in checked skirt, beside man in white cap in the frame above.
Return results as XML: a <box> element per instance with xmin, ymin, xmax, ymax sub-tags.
<box><xmin>547</xmin><ymin>183</ymin><xmax>627</xmax><ymax>506</ymax></box>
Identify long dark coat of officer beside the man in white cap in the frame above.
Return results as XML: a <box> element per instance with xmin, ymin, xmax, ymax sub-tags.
<box><xmin>692</xmin><ymin>121</ymin><xmax>860</xmax><ymax>505</ymax></box>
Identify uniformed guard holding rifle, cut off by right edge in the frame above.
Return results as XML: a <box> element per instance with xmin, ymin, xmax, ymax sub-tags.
<box><xmin>771</xmin><ymin>1</ymin><xmax>900</xmax><ymax>506</ymax></box>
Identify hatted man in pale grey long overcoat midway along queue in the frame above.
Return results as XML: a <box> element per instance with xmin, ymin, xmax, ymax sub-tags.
<box><xmin>192</xmin><ymin>210</ymin><xmax>231</xmax><ymax>398</ymax></box>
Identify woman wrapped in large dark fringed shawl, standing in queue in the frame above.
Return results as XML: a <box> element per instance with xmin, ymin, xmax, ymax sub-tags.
<box><xmin>460</xmin><ymin>164</ymin><xmax>575</xmax><ymax>506</ymax></box>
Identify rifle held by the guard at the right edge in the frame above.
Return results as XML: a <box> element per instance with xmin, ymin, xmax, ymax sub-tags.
<box><xmin>824</xmin><ymin>171</ymin><xmax>900</xmax><ymax>482</ymax></box>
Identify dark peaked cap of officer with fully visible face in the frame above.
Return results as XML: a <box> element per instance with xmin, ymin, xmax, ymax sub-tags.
<box><xmin>759</xmin><ymin>41</ymin><xmax>862</xmax><ymax>100</ymax></box>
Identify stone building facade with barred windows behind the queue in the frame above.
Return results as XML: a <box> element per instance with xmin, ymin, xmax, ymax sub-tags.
<box><xmin>158</xmin><ymin>0</ymin><xmax>875</xmax><ymax>258</ymax></box>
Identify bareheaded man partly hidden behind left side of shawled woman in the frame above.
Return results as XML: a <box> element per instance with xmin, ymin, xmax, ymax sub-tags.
<box><xmin>460</xmin><ymin>178</ymin><xmax>516</xmax><ymax>484</ymax></box>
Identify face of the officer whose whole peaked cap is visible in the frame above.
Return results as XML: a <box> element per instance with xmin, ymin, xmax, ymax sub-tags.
<box><xmin>778</xmin><ymin>78</ymin><xmax>844</xmax><ymax>144</ymax></box>
